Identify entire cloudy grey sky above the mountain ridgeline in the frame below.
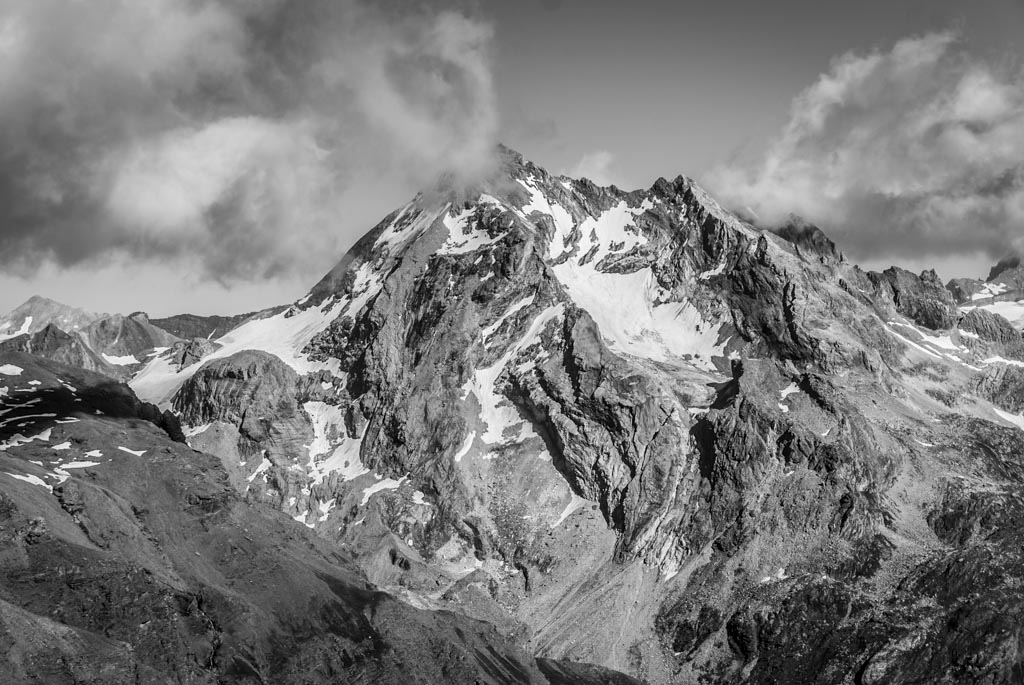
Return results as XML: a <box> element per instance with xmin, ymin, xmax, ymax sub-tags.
<box><xmin>0</xmin><ymin>0</ymin><xmax>1024</xmax><ymax>316</ymax></box>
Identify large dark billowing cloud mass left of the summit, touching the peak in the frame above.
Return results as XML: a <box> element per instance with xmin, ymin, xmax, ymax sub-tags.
<box><xmin>0</xmin><ymin>0</ymin><xmax>498</xmax><ymax>282</ymax></box>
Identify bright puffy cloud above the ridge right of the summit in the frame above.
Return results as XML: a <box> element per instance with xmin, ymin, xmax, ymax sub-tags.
<box><xmin>707</xmin><ymin>33</ymin><xmax>1024</xmax><ymax>258</ymax></box>
